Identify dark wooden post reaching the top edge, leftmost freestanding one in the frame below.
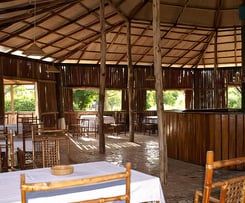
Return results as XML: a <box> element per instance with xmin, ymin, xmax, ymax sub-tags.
<box><xmin>98</xmin><ymin>0</ymin><xmax>106</xmax><ymax>153</ymax></box>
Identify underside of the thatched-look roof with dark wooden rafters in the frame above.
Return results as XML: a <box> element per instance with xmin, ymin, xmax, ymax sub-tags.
<box><xmin>0</xmin><ymin>0</ymin><xmax>242</xmax><ymax>68</ymax></box>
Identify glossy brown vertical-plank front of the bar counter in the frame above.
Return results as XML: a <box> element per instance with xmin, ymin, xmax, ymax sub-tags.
<box><xmin>164</xmin><ymin>111</ymin><xmax>245</xmax><ymax>164</ymax></box>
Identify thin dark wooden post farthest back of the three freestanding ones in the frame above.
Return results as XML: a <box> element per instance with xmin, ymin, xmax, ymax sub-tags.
<box><xmin>127</xmin><ymin>21</ymin><xmax>135</xmax><ymax>142</ymax></box>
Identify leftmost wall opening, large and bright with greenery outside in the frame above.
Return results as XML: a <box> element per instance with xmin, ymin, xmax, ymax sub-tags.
<box><xmin>4</xmin><ymin>79</ymin><xmax>38</xmax><ymax>124</ymax></box>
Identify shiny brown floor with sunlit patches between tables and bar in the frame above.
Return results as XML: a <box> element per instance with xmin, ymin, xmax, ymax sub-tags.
<box><xmin>61</xmin><ymin>134</ymin><xmax>245</xmax><ymax>203</ymax></box>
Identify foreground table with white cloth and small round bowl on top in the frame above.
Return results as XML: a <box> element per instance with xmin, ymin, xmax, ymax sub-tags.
<box><xmin>0</xmin><ymin>161</ymin><xmax>165</xmax><ymax>203</ymax></box>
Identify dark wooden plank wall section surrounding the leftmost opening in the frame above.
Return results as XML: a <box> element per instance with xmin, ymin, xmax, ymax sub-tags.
<box><xmin>0</xmin><ymin>54</ymin><xmax>58</xmax><ymax>123</ymax></box>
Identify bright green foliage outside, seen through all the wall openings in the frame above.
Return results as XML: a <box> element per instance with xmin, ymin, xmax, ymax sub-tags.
<box><xmin>4</xmin><ymin>85</ymin><xmax>241</xmax><ymax>112</ymax></box>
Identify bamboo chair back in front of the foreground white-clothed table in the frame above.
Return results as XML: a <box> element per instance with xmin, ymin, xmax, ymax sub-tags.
<box><xmin>20</xmin><ymin>163</ymin><xmax>131</xmax><ymax>203</ymax></box>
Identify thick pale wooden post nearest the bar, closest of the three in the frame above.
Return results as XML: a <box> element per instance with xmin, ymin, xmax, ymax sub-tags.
<box><xmin>152</xmin><ymin>0</ymin><xmax>168</xmax><ymax>184</ymax></box>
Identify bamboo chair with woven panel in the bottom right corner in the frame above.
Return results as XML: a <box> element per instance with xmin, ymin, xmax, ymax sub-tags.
<box><xmin>194</xmin><ymin>151</ymin><xmax>245</xmax><ymax>203</ymax></box>
